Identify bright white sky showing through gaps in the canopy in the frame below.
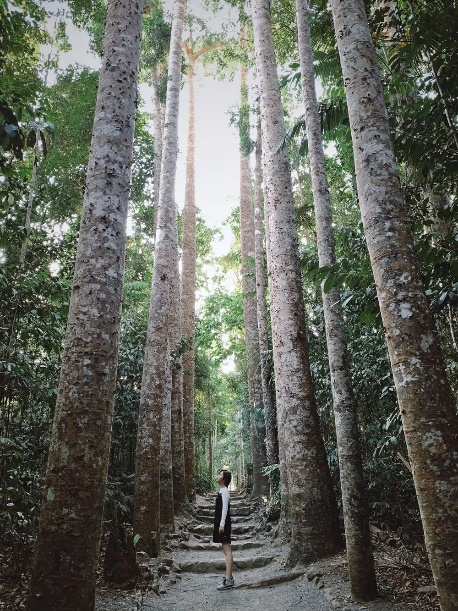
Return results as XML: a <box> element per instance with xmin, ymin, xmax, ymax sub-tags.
<box><xmin>56</xmin><ymin>0</ymin><xmax>239</xmax><ymax>254</ymax></box>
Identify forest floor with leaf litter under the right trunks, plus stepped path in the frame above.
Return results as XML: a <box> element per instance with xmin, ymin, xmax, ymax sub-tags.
<box><xmin>0</xmin><ymin>497</ymin><xmax>439</xmax><ymax>611</ymax></box>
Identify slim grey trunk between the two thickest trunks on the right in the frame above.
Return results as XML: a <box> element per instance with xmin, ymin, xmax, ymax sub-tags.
<box><xmin>296</xmin><ymin>0</ymin><xmax>377</xmax><ymax>600</ymax></box>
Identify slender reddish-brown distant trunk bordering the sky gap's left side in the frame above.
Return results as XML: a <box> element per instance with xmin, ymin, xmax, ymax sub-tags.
<box><xmin>181</xmin><ymin>53</ymin><xmax>196</xmax><ymax>502</ymax></box>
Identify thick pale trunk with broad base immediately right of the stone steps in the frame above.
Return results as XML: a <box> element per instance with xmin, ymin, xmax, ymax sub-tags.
<box><xmin>253</xmin><ymin>0</ymin><xmax>340</xmax><ymax>562</ymax></box>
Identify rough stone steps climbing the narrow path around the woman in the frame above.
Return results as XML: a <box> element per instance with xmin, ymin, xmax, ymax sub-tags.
<box><xmin>126</xmin><ymin>491</ymin><xmax>337</xmax><ymax>611</ymax></box>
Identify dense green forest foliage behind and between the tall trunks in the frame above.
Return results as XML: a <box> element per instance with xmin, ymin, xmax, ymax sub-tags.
<box><xmin>0</xmin><ymin>0</ymin><xmax>458</xmax><ymax>608</ymax></box>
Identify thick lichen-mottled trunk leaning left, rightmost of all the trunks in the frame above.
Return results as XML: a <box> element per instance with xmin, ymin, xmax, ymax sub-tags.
<box><xmin>331</xmin><ymin>0</ymin><xmax>458</xmax><ymax>611</ymax></box>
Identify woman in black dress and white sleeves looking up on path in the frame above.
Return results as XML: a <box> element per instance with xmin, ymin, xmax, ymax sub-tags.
<box><xmin>213</xmin><ymin>469</ymin><xmax>234</xmax><ymax>590</ymax></box>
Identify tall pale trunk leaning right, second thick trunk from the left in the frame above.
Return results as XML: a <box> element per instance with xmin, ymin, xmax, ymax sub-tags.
<box><xmin>134</xmin><ymin>0</ymin><xmax>186</xmax><ymax>555</ymax></box>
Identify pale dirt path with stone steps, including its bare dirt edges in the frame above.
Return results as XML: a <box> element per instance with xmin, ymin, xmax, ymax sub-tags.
<box><xmin>96</xmin><ymin>494</ymin><xmax>412</xmax><ymax>611</ymax></box>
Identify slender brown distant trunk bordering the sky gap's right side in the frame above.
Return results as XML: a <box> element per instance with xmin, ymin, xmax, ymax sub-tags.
<box><xmin>240</xmin><ymin>59</ymin><xmax>268</xmax><ymax>496</ymax></box>
